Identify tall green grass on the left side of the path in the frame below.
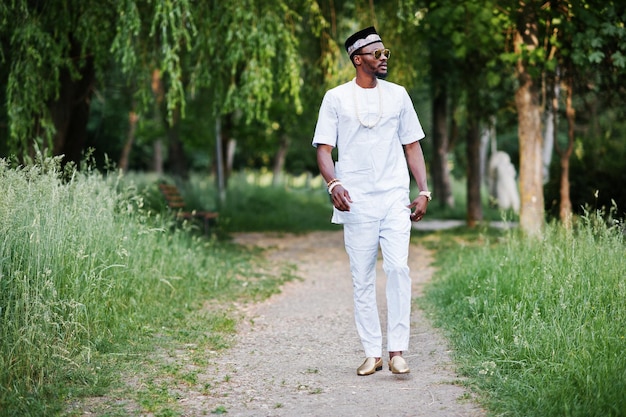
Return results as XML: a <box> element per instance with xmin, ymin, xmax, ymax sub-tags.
<box><xmin>0</xmin><ymin>159</ymin><xmax>288</xmax><ymax>416</ymax></box>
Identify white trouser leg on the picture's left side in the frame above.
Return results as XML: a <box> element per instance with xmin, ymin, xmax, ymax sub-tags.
<box><xmin>344</xmin><ymin>222</ymin><xmax>382</xmax><ymax>357</ymax></box>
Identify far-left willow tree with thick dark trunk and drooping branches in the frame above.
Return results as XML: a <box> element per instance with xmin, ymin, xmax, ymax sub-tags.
<box><xmin>0</xmin><ymin>0</ymin><xmax>189</xmax><ymax>162</ymax></box>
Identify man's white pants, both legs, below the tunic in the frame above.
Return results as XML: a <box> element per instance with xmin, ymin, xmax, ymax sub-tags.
<box><xmin>344</xmin><ymin>203</ymin><xmax>411</xmax><ymax>357</ymax></box>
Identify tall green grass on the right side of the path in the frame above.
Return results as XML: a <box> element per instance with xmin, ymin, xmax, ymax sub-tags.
<box><xmin>424</xmin><ymin>213</ymin><xmax>626</xmax><ymax>417</ymax></box>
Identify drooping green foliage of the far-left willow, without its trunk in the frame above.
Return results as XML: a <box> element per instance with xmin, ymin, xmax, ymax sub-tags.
<box><xmin>0</xmin><ymin>0</ymin><xmax>189</xmax><ymax>150</ymax></box>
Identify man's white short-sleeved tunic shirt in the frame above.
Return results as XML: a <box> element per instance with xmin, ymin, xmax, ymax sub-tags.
<box><xmin>313</xmin><ymin>76</ymin><xmax>425</xmax><ymax>223</ymax></box>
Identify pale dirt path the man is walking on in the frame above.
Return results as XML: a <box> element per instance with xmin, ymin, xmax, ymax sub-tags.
<box><xmin>189</xmin><ymin>232</ymin><xmax>484</xmax><ymax>417</ymax></box>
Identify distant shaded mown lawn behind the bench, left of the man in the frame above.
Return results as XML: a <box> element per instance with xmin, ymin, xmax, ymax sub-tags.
<box><xmin>119</xmin><ymin>170</ymin><xmax>339</xmax><ymax>234</ymax></box>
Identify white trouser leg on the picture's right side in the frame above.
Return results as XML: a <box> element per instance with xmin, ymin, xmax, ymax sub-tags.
<box><xmin>380</xmin><ymin>203</ymin><xmax>411</xmax><ymax>352</ymax></box>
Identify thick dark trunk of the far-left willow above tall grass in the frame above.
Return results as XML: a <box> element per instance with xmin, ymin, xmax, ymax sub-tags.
<box><xmin>49</xmin><ymin>42</ymin><xmax>95</xmax><ymax>166</ymax></box>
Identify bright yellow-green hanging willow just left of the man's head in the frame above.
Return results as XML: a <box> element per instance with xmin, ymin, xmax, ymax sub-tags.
<box><xmin>191</xmin><ymin>0</ymin><xmax>324</xmax><ymax>191</ymax></box>
